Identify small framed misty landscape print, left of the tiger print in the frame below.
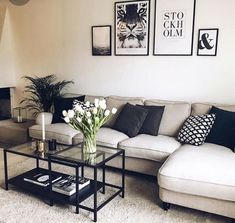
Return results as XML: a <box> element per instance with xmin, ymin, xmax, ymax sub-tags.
<box><xmin>91</xmin><ymin>25</ymin><xmax>112</xmax><ymax>56</ymax></box>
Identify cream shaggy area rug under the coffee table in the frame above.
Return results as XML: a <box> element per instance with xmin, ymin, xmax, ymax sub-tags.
<box><xmin>0</xmin><ymin>151</ymin><xmax>232</xmax><ymax>223</ymax></box>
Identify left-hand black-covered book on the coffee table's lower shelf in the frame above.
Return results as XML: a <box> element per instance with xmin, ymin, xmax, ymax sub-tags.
<box><xmin>24</xmin><ymin>170</ymin><xmax>62</xmax><ymax>187</ymax></box>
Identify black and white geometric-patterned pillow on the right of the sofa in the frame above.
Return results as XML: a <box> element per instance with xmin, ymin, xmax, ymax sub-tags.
<box><xmin>178</xmin><ymin>114</ymin><xmax>216</xmax><ymax>146</ymax></box>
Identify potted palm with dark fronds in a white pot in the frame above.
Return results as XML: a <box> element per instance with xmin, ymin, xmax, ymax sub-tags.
<box><xmin>20</xmin><ymin>74</ymin><xmax>74</xmax><ymax>124</ymax></box>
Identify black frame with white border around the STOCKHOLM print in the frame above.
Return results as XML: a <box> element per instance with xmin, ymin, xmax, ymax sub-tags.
<box><xmin>153</xmin><ymin>0</ymin><xmax>196</xmax><ymax>56</ymax></box>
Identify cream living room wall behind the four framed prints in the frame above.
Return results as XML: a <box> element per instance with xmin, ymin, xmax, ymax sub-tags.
<box><xmin>3</xmin><ymin>0</ymin><xmax>235</xmax><ymax>103</ymax></box>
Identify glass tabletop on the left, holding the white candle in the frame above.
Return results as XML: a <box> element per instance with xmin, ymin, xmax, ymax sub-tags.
<box><xmin>4</xmin><ymin>141</ymin><xmax>69</xmax><ymax>160</ymax></box>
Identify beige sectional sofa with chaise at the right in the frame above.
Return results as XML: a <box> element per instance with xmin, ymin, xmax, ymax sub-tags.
<box><xmin>29</xmin><ymin>96</ymin><xmax>235</xmax><ymax>218</ymax></box>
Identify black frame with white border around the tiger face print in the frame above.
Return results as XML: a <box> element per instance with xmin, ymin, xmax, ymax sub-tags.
<box><xmin>114</xmin><ymin>0</ymin><xmax>151</xmax><ymax>56</ymax></box>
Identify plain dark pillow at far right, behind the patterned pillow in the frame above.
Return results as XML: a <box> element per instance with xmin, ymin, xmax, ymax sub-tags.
<box><xmin>206</xmin><ymin>106</ymin><xmax>235</xmax><ymax>150</ymax></box>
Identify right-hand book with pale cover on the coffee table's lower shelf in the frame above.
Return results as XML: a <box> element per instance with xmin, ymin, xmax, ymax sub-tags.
<box><xmin>52</xmin><ymin>176</ymin><xmax>90</xmax><ymax>196</ymax></box>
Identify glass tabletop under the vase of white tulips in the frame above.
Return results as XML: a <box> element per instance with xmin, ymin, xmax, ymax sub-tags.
<box><xmin>51</xmin><ymin>145</ymin><xmax>123</xmax><ymax>166</ymax></box>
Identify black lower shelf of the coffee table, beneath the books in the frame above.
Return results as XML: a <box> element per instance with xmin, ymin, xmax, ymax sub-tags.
<box><xmin>8</xmin><ymin>168</ymin><xmax>103</xmax><ymax>205</ymax></box>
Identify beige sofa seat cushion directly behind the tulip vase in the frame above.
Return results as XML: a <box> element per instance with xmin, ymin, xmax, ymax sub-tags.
<box><xmin>74</xmin><ymin>127</ymin><xmax>129</xmax><ymax>148</ymax></box>
